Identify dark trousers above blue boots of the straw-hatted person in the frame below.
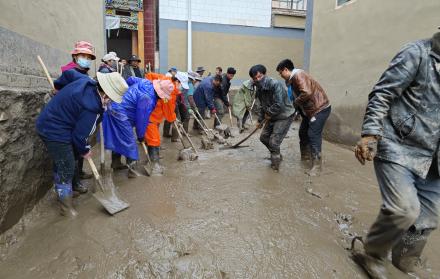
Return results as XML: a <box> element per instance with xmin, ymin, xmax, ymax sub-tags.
<box><xmin>43</xmin><ymin>139</ymin><xmax>79</xmax><ymax>185</ymax></box>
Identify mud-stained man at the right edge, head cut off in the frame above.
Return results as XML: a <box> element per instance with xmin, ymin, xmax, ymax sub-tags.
<box><xmin>354</xmin><ymin>30</ymin><xmax>440</xmax><ymax>278</ymax></box>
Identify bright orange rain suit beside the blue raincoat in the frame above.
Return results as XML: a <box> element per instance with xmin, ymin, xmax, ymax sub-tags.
<box><xmin>144</xmin><ymin>73</ymin><xmax>181</xmax><ymax>147</ymax></box>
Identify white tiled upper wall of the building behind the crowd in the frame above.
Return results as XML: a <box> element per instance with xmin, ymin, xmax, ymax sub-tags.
<box><xmin>159</xmin><ymin>0</ymin><xmax>272</xmax><ymax>27</ymax></box>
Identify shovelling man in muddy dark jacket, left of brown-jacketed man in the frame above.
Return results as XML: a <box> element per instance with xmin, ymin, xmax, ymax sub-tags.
<box><xmin>249</xmin><ymin>65</ymin><xmax>295</xmax><ymax>171</ymax></box>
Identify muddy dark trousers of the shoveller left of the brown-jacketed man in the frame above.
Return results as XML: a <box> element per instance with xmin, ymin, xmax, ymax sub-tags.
<box><xmin>260</xmin><ymin>115</ymin><xmax>293</xmax><ymax>155</ymax></box>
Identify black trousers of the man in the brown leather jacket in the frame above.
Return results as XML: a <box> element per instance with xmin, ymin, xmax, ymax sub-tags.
<box><xmin>299</xmin><ymin>107</ymin><xmax>331</xmax><ymax>154</ymax></box>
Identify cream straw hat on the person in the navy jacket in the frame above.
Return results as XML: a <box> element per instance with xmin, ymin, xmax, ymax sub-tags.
<box><xmin>96</xmin><ymin>72</ymin><xmax>128</xmax><ymax>103</ymax></box>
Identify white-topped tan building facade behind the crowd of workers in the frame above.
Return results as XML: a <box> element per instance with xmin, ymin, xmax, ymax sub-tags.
<box><xmin>158</xmin><ymin>0</ymin><xmax>306</xmax><ymax>84</ymax></box>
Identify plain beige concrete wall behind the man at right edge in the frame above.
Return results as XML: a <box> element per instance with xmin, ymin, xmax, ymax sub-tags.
<box><xmin>306</xmin><ymin>0</ymin><xmax>440</xmax><ymax>147</ymax></box>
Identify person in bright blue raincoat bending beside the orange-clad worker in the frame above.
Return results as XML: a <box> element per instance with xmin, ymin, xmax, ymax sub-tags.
<box><xmin>103</xmin><ymin>77</ymin><xmax>157</xmax><ymax>178</ymax></box>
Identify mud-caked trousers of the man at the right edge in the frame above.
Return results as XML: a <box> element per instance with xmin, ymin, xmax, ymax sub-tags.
<box><xmin>365</xmin><ymin>159</ymin><xmax>440</xmax><ymax>262</ymax></box>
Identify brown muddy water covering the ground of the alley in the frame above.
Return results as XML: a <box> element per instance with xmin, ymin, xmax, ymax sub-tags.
<box><xmin>0</xmin><ymin>123</ymin><xmax>440</xmax><ymax>278</ymax></box>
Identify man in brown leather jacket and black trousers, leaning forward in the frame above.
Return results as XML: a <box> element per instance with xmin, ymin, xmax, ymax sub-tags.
<box><xmin>276</xmin><ymin>59</ymin><xmax>331</xmax><ymax>176</ymax></box>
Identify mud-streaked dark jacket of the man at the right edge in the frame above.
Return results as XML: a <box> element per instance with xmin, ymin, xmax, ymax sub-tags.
<box><xmin>362</xmin><ymin>33</ymin><xmax>440</xmax><ymax>178</ymax></box>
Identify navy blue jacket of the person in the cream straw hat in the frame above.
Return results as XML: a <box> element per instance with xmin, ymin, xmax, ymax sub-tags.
<box><xmin>36</xmin><ymin>70</ymin><xmax>103</xmax><ymax>155</ymax></box>
